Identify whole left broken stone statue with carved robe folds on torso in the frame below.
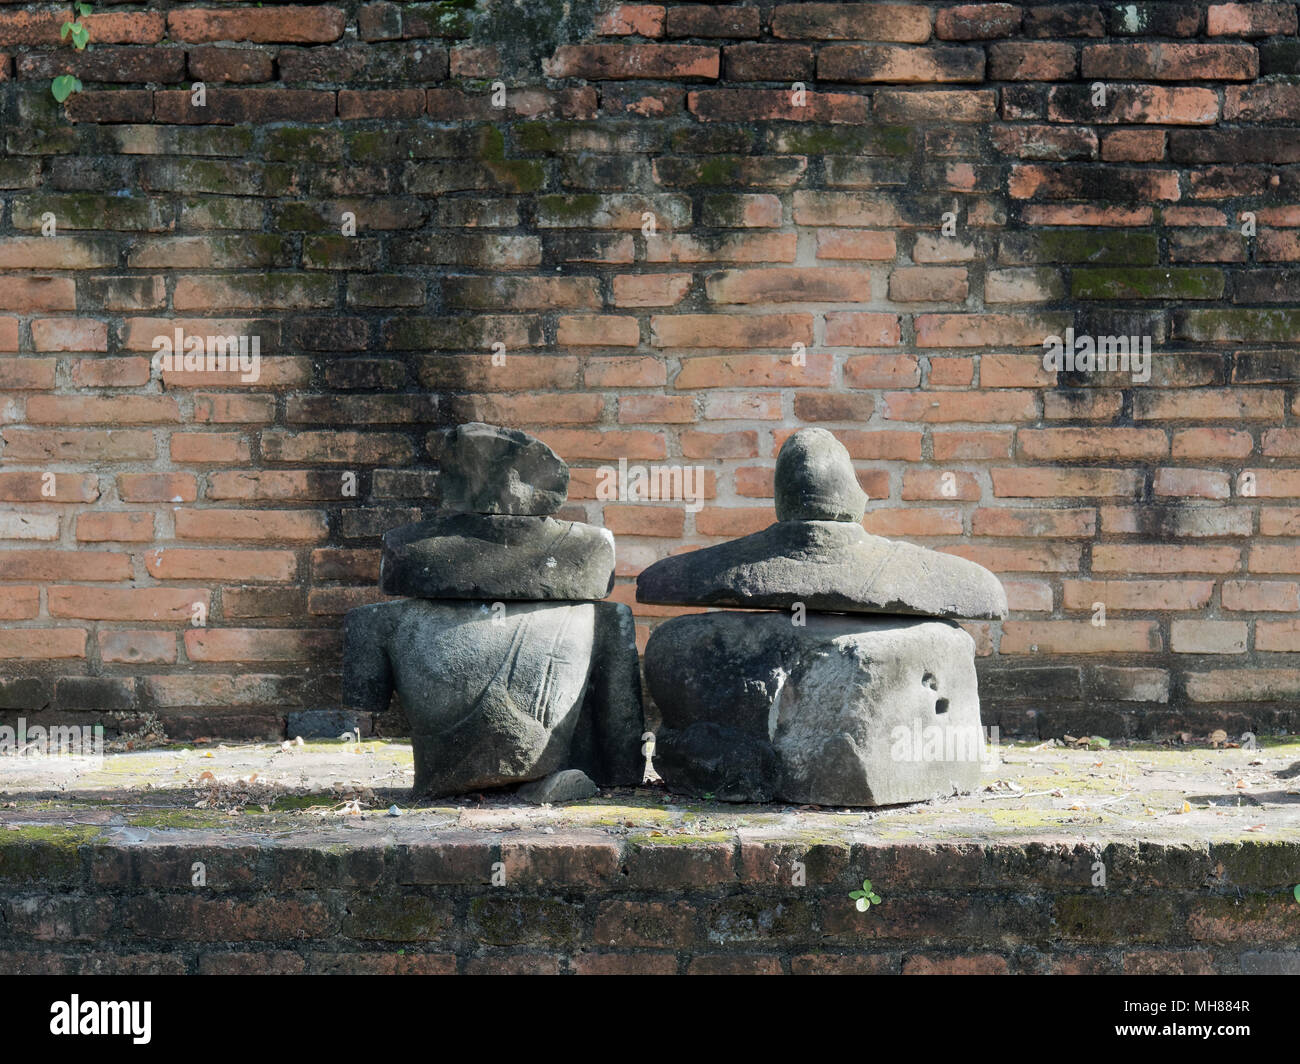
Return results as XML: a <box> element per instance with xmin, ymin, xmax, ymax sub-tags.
<box><xmin>345</xmin><ymin>424</ymin><xmax>644</xmax><ymax>795</ymax></box>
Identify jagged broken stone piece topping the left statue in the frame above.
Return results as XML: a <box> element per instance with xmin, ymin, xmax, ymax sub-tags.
<box><xmin>433</xmin><ymin>421</ymin><xmax>568</xmax><ymax>516</ymax></box>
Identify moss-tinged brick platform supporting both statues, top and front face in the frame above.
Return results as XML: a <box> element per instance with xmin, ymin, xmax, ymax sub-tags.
<box><xmin>0</xmin><ymin>740</ymin><xmax>1300</xmax><ymax>974</ymax></box>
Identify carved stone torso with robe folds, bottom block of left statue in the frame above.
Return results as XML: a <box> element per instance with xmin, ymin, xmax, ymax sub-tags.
<box><xmin>343</xmin><ymin>598</ymin><xmax>644</xmax><ymax>795</ymax></box>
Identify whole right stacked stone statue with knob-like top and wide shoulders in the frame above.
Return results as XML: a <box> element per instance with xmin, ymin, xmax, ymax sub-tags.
<box><xmin>637</xmin><ymin>429</ymin><xmax>1006</xmax><ymax>805</ymax></box>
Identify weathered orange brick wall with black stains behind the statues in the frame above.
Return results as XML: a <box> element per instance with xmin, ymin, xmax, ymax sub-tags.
<box><xmin>0</xmin><ymin>0</ymin><xmax>1300</xmax><ymax>736</ymax></box>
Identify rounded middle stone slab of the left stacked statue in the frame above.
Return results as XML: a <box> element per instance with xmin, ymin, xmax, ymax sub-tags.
<box><xmin>380</xmin><ymin>514</ymin><xmax>614</xmax><ymax>602</ymax></box>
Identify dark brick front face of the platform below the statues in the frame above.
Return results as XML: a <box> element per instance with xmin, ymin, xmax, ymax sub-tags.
<box><xmin>0</xmin><ymin>826</ymin><xmax>1300</xmax><ymax>967</ymax></box>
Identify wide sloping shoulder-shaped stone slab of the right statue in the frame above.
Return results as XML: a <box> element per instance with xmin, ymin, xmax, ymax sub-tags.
<box><xmin>637</xmin><ymin>520</ymin><xmax>1006</xmax><ymax>619</ymax></box>
